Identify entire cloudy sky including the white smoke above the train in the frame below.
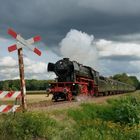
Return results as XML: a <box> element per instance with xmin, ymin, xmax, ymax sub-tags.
<box><xmin>0</xmin><ymin>0</ymin><xmax>140</xmax><ymax>80</ymax></box>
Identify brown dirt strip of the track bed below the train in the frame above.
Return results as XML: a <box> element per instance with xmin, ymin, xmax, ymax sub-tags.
<box><xmin>28</xmin><ymin>94</ymin><xmax>124</xmax><ymax>111</ymax></box>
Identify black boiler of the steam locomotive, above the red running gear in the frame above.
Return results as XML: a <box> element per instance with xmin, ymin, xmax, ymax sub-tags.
<box><xmin>48</xmin><ymin>58</ymin><xmax>99</xmax><ymax>82</ymax></box>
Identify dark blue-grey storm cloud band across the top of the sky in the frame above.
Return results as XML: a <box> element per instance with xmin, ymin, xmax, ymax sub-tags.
<box><xmin>0</xmin><ymin>0</ymin><xmax>140</xmax><ymax>45</ymax></box>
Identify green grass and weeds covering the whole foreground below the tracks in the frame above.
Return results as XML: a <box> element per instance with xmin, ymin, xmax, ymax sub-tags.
<box><xmin>0</xmin><ymin>92</ymin><xmax>140</xmax><ymax>140</ymax></box>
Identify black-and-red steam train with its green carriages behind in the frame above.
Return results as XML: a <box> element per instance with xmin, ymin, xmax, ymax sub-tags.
<box><xmin>47</xmin><ymin>58</ymin><xmax>135</xmax><ymax>101</ymax></box>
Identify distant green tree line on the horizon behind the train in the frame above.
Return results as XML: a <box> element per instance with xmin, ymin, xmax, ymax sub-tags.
<box><xmin>0</xmin><ymin>73</ymin><xmax>140</xmax><ymax>91</ymax></box>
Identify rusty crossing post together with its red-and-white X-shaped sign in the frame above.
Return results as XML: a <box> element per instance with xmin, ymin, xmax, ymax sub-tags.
<box><xmin>8</xmin><ymin>28</ymin><xmax>41</xmax><ymax>111</ymax></box>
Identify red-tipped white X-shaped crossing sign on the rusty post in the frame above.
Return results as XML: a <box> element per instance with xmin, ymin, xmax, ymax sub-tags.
<box><xmin>8</xmin><ymin>28</ymin><xmax>41</xmax><ymax>56</ymax></box>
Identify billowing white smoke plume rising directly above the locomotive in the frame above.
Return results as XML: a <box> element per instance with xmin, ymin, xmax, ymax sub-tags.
<box><xmin>60</xmin><ymin>29</ymin><xmax>98</xmax><ymax>69</ymax></box>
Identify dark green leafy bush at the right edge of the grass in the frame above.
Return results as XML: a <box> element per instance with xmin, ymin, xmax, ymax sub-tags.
<box><xmin>111</xmin><ymin>96</ymin><xmax>140</xmax><ymax>125</ymax></box>
